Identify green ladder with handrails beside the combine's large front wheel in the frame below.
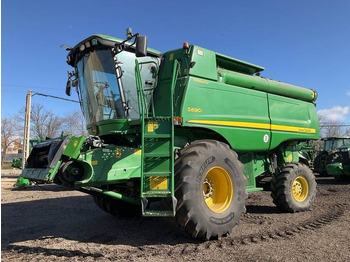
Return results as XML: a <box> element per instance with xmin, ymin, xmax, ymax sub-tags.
<box><xmin>135</xmin><ymin>60</ymin><xmax>179</xmax><ymax>217</ymax></box>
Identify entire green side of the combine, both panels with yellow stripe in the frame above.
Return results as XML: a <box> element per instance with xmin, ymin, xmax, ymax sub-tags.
<box><xmin>175</xmin><ymin>77</ymin><xmax>319</xmax><ymax>152</ymax></box>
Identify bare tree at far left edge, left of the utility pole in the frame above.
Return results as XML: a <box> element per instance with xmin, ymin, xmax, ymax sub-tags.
<box><xmin>1</xmin><ymin>117</ymin><xmax>21</xmax><ymax>166</ymax></box>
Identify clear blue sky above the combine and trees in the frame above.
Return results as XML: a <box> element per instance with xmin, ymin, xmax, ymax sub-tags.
<box><xmin>1</xmin><ymin>0</ymin><xmax>350</xmax><ymax>123</ymax></box>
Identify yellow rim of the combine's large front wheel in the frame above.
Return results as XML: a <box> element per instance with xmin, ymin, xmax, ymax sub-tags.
<box><xmin>203</xmin><ymin>166</ymin><xmax>234</xmax><ymax>213</ymax></box>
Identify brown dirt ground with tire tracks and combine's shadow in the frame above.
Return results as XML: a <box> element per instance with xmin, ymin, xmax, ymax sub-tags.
<box><xmin>1</xmin><ymin>169</ymin><xmax>350</xmax><ymax>261</ymax></box>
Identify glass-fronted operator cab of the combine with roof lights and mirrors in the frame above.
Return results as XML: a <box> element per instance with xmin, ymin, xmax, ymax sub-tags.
<box><xmin>66</xmin><ymin>31</ymin><xmax>161</xmax><ymax>135</ymax></box>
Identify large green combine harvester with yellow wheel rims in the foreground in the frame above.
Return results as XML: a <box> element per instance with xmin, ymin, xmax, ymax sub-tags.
<box><xmin>21</xmin><ymin>30</ymin><xmax>319</xmax><ymax>240</ymax></box>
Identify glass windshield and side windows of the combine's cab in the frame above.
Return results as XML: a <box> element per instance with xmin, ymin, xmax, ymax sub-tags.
<box><xmin>77</xmin><ymin>49</ymin><xmax>158</xmax><ymax>125</ymax></box>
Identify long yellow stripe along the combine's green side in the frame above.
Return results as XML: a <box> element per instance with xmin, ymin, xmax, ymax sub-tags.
<box><xmin>187</xmin><ymin>120</ymin><xmax>316</xmax><ymax>134</ymax></box>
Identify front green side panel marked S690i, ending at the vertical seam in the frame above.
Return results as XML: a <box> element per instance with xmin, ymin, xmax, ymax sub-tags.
<box><xmin>175</xmin><ymin>78</ymin><xmax>270</xmax><ymax>151</ymax></box>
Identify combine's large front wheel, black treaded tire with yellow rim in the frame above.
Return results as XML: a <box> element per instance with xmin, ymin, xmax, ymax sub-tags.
<box><xmin>175</xmin><ymin>140</ymin><xmax>247</xmax><ymax>240</ymax></box>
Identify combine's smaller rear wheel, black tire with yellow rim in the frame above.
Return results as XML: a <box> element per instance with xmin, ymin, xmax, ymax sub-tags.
<box><xmin>271</xmin><ymin>163</ymin><xmax>316</xmax><ymax>213</ymax></box>
